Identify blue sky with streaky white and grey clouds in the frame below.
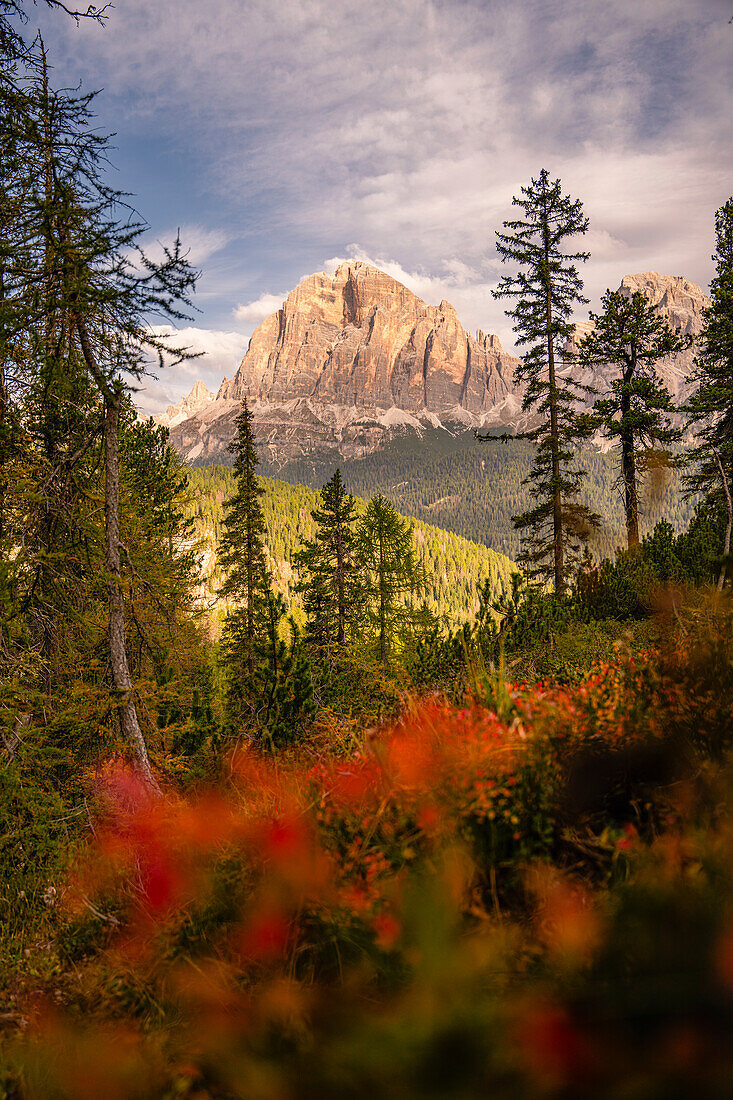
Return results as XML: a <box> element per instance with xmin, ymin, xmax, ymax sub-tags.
<box><xmin>33</xmin><ymin>0</ymin><xmax>733</xmax><ymax>413</ymax></box>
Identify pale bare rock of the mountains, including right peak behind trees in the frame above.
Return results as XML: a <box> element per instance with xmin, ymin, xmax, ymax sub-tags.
<box><xmin>158</xmin><ymin>270</ymin><xmax>709</xmax><ymax>462</ymax></box>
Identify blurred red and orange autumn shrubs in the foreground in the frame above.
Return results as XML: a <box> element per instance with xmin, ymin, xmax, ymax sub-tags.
<box><xmin>9</xmin><ymin>655</ymin><xmax>733</xmax><ymax>1100</ymax></box>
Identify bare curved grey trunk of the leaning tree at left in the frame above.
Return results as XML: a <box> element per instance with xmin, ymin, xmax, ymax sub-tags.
<box><xmin>105</xmin><ymin>389</ymin><xmax>160</xmax><ymax>794</ymax></box>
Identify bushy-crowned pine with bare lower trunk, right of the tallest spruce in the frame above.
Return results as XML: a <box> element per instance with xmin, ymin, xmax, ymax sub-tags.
<box><xmin>578</xmin><ymin>290</ymin><xmax>686</xmax><ymax>547</ymax></box>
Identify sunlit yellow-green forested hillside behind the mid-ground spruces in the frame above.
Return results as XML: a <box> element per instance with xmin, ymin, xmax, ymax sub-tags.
<box><xmin>187</xmin><ymin>466</ymin><xmax>514</xmax><ymax>626</ymax></box>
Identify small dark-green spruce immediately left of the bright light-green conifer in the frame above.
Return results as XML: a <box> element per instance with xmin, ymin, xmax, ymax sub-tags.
<box><xmin>295</xmin><ymin>470</ymin><xmax>358</xmax><ymax>646</ymax></box>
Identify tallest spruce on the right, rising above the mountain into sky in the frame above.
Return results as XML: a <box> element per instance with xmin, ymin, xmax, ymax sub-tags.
<box><xmin>493</xmin><ymin>168</ymin><xmax>599</xmax><ymax>594</ymax></box>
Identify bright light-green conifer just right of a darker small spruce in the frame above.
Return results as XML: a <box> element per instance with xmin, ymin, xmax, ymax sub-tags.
<box><xmin>355</xmin><ymin>493</ymin><xmax>425</xmax><ymax>669</ymax></box>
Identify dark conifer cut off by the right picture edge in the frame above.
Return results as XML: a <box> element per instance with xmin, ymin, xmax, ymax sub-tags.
<box><xmin>686</xmin><ymin>197</ymin><xmax>733</xmax><ymax>589</ymax></box>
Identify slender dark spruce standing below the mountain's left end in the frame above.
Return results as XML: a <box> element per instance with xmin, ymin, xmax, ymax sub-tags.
<box><xmin>219</xmin><ymin>399</ymin><xmax>270</xmax><ymax>686</ymax></box>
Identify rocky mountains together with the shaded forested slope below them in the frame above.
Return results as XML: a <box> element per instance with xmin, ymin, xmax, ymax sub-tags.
<box><xmin>156</xmin><ymin>261</ymin><xmax>709</xmax><ymax>557</ymax></box>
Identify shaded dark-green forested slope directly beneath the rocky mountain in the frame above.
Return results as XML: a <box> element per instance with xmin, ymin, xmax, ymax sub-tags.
<box><xmin>250</xmin><ymin>429</ymin><xmax>693</xmax><ymax>559</ymax></box>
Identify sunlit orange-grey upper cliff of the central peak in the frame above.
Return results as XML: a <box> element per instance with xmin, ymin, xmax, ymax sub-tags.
<box><xmin>217</xmin><ymin>261</ymin><xmax>517</xmax><ymax>414</ymax></box>
